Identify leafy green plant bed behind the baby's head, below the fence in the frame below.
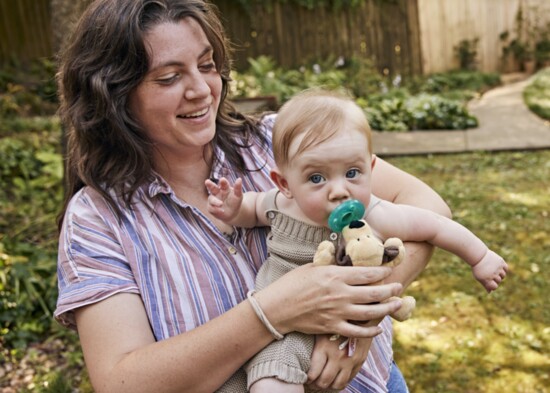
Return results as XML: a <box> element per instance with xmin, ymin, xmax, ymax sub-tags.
<box><xmin>230</xmin><ymin>56</ymin><xmax>500</xmax><ymax>131</ymax></box>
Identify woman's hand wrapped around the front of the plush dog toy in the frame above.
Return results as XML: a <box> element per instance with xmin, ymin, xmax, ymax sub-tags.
<box><xmin>255</xmin><ymin>264</ymin><xmax>402</xmax><ymax>338</ymax></box>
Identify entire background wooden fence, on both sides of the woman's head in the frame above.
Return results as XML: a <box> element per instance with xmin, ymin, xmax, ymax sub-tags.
<box><xmin>0</xmin><ymin>0</ymin><xmax>550</xmax><ymax>74</ymax></box>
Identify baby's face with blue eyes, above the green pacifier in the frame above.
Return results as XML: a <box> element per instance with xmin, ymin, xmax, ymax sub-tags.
<box><xmin>284</xmin><ymin>127</ymin><xmax>371</xmax><ymax>227</ymax></box>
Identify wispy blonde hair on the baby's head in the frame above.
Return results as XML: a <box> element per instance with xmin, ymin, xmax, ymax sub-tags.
<box><xmin>273</xmin><ymin>89</ymin><xmax>372</xmax><ymax>168</ymax></box>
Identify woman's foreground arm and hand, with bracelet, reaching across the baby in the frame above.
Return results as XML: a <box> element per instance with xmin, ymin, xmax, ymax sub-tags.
<box><xmin>76</xmin><ymin>264</ymin><xmax>401</xmax><ymax>393</ymax></box>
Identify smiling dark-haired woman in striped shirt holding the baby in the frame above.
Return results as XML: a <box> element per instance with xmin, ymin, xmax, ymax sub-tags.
<box><xmin>55</xmin><ymin>0</ymin><xmax>449</xmax><ymax>392</ymax></box>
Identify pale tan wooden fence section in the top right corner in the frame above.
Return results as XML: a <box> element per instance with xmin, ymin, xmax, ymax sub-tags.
<box><xmin>417</xmin><ymin>0</ymin><xmax>550</xmax><ymax>74</ymax></box>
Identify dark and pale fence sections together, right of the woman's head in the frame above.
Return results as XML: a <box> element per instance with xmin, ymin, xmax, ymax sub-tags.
<box><xmin>215</xmin><ymin>0</ymin><xmax>550</xmax><ymax>74</ymax></box>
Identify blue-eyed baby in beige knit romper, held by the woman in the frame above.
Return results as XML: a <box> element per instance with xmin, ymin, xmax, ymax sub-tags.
<box><xmin>206</xmin><ymin>90</ymin><xmax>508</xmax><ymax>393</ymax></box>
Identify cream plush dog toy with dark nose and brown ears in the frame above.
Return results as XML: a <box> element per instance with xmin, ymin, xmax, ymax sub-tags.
<box><xmin>313</xmin><ymin>220</ymin><xmax>416</xmax><ymax>321</ymax></box>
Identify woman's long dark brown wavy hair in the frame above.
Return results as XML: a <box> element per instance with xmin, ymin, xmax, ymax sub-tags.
<box><xmin>57</xmin><ymin>0</ymin><xmax>266</xmax><ymax>225</ymax></box>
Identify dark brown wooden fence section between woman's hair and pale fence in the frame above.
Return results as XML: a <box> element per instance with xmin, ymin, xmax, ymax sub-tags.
<box><xmin>214</xmin><ymin>0</ymin><xmax>422</xmax><ymax>74</ymax></box>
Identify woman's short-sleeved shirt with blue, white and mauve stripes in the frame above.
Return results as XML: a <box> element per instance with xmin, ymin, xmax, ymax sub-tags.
<box><xmin>55</xmin><ymin>116</ymin><xmax>392</xmax><ymax>392</ymax></box>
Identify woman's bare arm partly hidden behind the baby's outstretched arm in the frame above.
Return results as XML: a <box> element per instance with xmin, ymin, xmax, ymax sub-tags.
<box><xmin>372</xmin><ymin>157</ymin><xmax>451</xmax><ymax>288</ymax></box>
